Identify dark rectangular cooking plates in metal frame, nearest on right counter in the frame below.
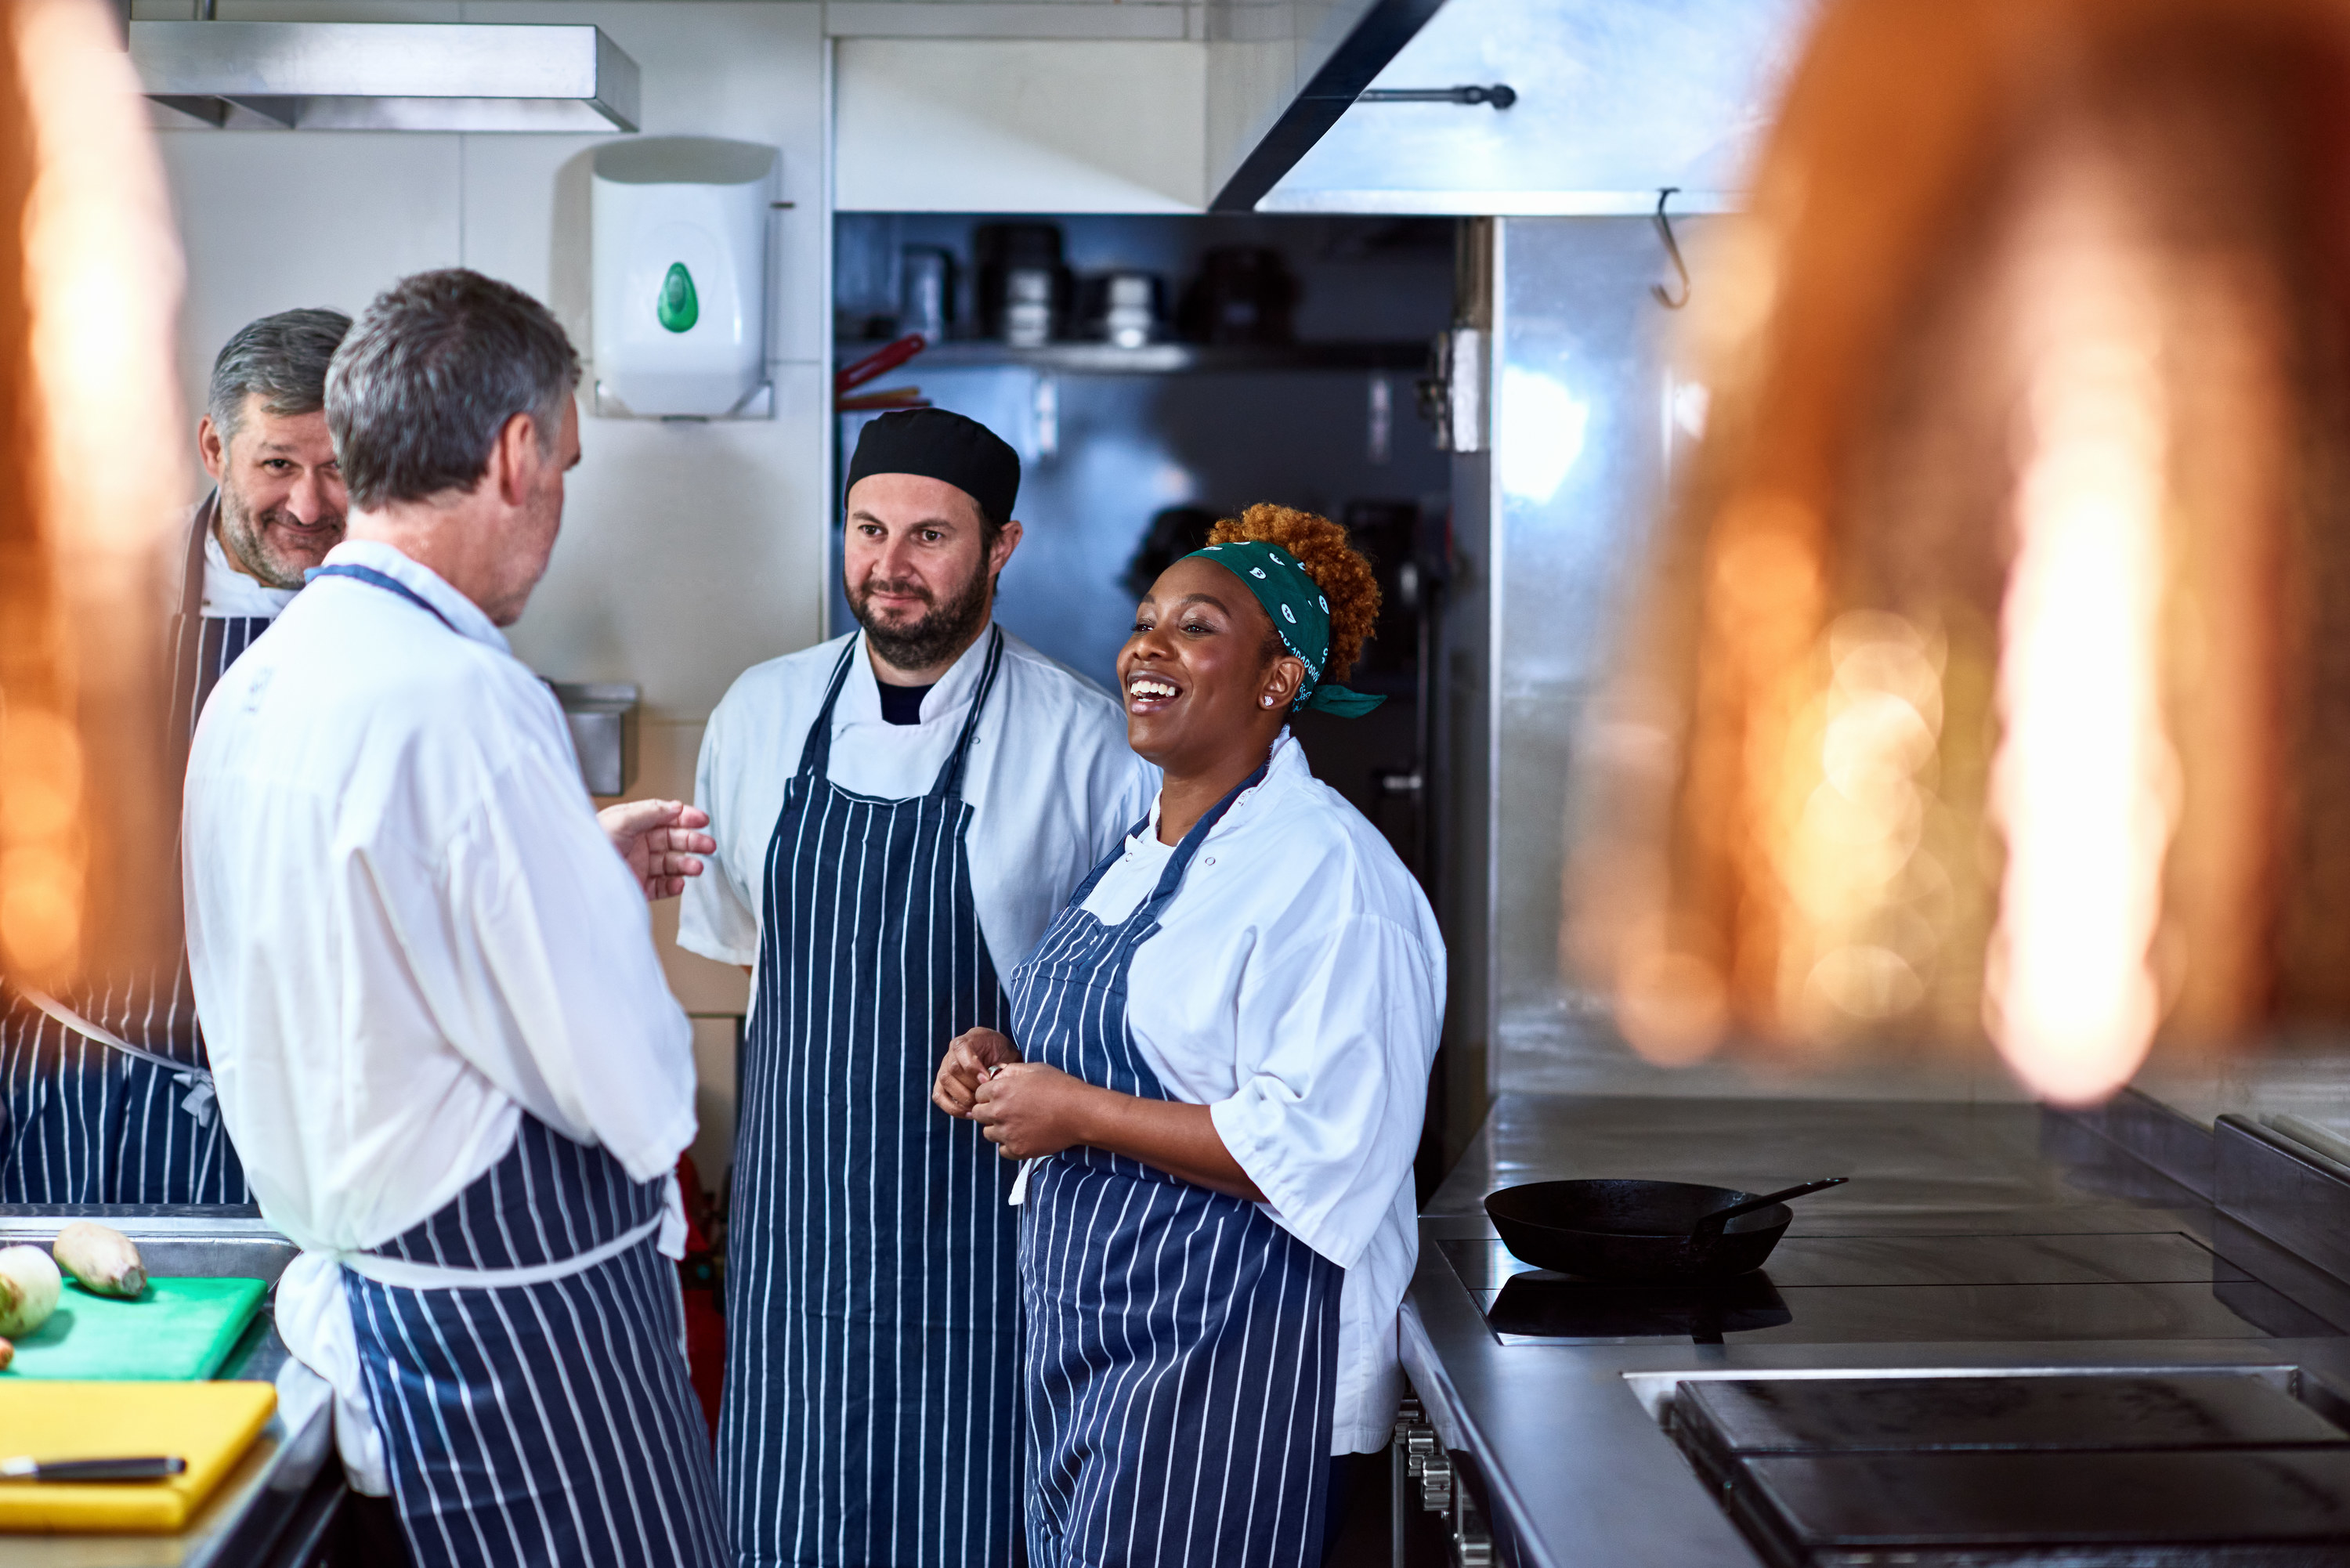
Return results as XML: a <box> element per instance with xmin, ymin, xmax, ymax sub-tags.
<box><xmin>1671</xmin><ymin>1373</ymin><xmax>2350</xmax><ymax>1568</ymax></box>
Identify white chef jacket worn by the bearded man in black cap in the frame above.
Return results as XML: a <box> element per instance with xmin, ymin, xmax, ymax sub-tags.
<box><xmin>677</xmin><ymin>632</ymin><xmax>1159</xmax><ymax>982</ymax></box>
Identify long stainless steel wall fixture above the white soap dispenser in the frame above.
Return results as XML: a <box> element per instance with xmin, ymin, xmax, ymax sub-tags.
<box><xmin>129</xmin><ymin>21</ymin><xmax>637</xmax><ymax>134</ymax></box>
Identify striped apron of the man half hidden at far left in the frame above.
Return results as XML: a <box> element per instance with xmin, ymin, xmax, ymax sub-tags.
<box><xmin>0</xmin><ymin>491</ymin><xmax>270</xmax><ymax>1204</ymax></box>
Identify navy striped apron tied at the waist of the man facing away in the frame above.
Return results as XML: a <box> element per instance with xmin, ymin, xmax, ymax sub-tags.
<box><xmin>343</xmin><ymin>1112</ymin><xmax>726</xmax><ymax>1568</ymax></box>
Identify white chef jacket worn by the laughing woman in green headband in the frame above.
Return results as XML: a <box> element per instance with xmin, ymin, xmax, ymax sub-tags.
<box><xmin>1086</xmin><ymin>731</ymin><xmax>1445</xmax><ymax>1453</ymax></box>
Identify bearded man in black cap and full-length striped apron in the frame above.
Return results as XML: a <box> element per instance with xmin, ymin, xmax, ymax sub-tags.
<box><xmin>677</xmin><ymin>409</ymin><xmax>1156</xmax><ymax>1568</ymax></box>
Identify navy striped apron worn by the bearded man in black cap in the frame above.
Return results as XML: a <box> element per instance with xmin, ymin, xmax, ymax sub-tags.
<box><xmin>719</xmin><ymin>630</ymin><xmax>1020</xmax><ymax>1568</ymax></box>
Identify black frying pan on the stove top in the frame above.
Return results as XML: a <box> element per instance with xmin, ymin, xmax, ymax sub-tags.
<box><xmin>1485</xmin><ymin>1180</ymin><xmax>1833</xmax><ymax>1281</ymax></box>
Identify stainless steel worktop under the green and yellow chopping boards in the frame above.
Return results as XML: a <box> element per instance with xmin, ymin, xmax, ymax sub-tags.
<box><xmin>0</xmin><ymin>1206</ymin><xmax>334</xmax><ymax>1568</ymax></box>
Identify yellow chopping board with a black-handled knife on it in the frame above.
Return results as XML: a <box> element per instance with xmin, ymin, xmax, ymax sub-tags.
<box><xmin>0</xmin><ymin>1380</ymin><xmax>277</xmax><ymax>1535</ymax></box>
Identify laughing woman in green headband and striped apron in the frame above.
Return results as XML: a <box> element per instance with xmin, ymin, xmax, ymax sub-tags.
<box><xmin>933</xmin><ymin>505</ymin><xmax>1443</xmax><ymax>1568</ymax></box>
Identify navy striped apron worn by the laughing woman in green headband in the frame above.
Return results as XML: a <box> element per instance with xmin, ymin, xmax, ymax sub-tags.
<box><xmin>1013</xmin><ymin>768</ymin><xmax>1347</xmax><ymax>1568</ymax></box>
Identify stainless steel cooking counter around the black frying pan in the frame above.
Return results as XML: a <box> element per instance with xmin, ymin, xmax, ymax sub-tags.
<box><xmin>1403</xmin><ymin>1096</ymin><xmax>2350</xmax><ymax>1568</ymax></box>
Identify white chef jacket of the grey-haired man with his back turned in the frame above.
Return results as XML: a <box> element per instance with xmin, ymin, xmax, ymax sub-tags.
<box><xmin>183</xmin><ymin>540</ymin><xmax>693</xmax><ymax>1253</ymax></box>
